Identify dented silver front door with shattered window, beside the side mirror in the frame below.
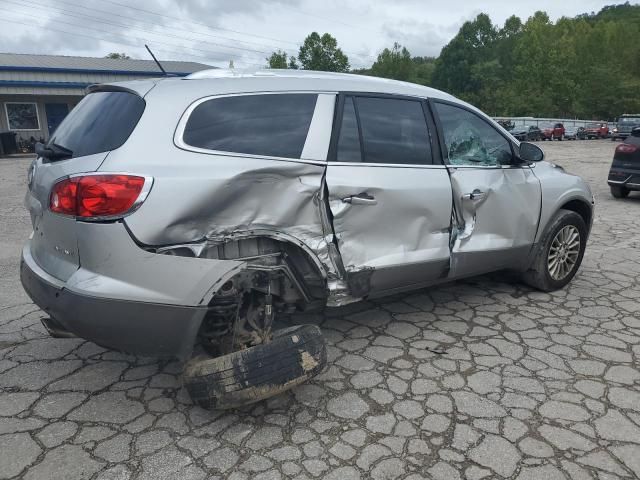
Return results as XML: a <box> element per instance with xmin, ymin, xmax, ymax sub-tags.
<box><xmin>434</xmin><ymin>101</ymin><xmax>542</xmax><ymax>277</ymax></box>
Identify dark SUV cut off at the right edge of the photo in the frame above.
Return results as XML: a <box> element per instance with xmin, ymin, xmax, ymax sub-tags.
<box><xmin>609</xmin><ymin>127</ymin><xmax>640</xmax><ymax>198</ymax></box>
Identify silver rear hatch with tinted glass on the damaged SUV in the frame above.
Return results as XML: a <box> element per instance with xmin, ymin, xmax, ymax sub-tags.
<box><xmin>25</xmin><ymin>86</ymin><xmax>148</xmax><ymax>281</ymax></box>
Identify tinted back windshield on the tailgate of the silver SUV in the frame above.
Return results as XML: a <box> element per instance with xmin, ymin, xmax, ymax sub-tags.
<box><xmin>48</xmin><ymin>92</ymin><xmax>145</xmax><ymax>158</ymax></box>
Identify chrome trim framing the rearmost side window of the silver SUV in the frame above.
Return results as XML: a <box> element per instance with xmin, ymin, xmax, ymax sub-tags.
<box><xmin>173</xmin><ymin>90</ymin><xmax>337</xmax><ymax>165</ymax></box>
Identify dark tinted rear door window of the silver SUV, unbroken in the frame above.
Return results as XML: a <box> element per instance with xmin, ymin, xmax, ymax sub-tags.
<box><xmin>336</xmin><ymin>97</ymin><xmax>432</xmax><ymax>165</ymax></box>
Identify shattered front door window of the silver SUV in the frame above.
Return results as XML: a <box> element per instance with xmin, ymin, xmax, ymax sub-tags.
<box><xmin>435</xmin><ymin>102</ymin><xmax>513</xmax><ymax>166</ymax></box>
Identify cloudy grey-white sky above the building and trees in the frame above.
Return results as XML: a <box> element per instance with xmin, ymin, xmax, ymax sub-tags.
<box><xmin>0</xmin><ymin>0</ymin><xmax>622</xmax><ymax>69</ymax></box>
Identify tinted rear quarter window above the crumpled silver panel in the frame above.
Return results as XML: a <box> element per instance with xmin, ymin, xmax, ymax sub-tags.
<box><xmin>182</xmin><ymin>93</ymin><xmax>317</xmax><ymax>158</ymax></box>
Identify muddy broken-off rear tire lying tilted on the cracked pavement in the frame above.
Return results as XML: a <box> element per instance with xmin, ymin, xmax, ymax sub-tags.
<box><xmin>184</xmin><ymin>325</ymin><xmax>327</xmax><ymax>409</ymax></box>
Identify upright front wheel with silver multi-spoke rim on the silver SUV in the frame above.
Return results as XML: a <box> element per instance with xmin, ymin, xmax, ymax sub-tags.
<box><xmin>523</xmin><ymin>210</ymin><xmax>587</xmax><ymax>292</ymax></box>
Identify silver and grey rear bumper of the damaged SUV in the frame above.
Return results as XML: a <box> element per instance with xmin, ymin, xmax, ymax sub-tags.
<box><xmin>20</xmin><ymin>222</ymin><xmax>244</xmax><ymax>358</ymax></box>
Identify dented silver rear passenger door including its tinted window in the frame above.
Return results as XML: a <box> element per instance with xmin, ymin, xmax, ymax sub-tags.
<box><xmin>326</xmin><ymin>95</ymin><xmax>452</xmax><ymax>296</ymax></box>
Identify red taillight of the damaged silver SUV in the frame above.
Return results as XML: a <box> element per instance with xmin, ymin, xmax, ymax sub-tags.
<box><xmin>49</xmin><ymin>174</ymin><xmax>152</xmax><ymax>219</ymax></box>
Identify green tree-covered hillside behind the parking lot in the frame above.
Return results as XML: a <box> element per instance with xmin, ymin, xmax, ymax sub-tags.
<box><xmin>267</xmin><ymin>2</ymin><xmax>640</xmax><ymax>119</ymax></box>
